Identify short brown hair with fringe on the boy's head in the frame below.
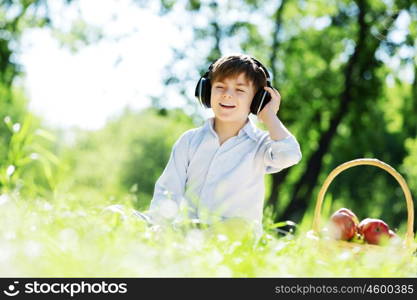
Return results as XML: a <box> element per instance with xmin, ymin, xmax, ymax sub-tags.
<box><xmin>208</xmin><ymin>54</ymin><xmax>266</xmax><ymax>93</ymax></box>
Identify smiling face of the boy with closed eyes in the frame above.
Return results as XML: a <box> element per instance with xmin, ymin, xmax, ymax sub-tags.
<box><xmin>210</xmin><ymin>73</ymin><xmax>256</xmax><ymax>122</ymax></box>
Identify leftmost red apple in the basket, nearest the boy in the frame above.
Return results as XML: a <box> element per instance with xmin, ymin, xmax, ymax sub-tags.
<box><xmin>330</xmin><ymin>212</ymin><xmax>357</xmax><ymax>241</ymax></box>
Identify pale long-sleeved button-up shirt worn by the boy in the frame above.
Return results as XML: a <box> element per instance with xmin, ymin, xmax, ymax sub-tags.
<box><xmin>150</xmin><ymin>118</ymin><xmax>302</xmax><ymax>232</ymax></box>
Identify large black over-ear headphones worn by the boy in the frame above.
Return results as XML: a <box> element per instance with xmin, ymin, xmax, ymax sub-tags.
<box><xmin>195</xmin><ymin>57</ymin><xmax>272</xmax><ymax>115</ymax></box>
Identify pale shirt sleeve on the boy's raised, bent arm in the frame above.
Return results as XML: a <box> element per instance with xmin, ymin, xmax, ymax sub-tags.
<box><xmin>263</xmin><ymin>135</ymin><xmax>302</xmax><ymax>174</ymax></box>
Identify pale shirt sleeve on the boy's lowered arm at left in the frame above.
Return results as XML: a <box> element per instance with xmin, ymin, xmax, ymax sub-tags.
<box><xmin>148</xmin><ymin>132</ymin><xmax>189</xmax><ymax>222</ymax></box>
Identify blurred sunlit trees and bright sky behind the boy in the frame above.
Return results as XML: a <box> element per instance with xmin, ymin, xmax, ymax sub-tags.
<box><xmin>0</xmin><ymin>0</ymin><xmax>417</xmax><ymax>228</ymax></box>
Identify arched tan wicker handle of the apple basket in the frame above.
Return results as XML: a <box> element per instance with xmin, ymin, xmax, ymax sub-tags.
<box><xmin>313</xmin><ymin>158</ymin><xmax>414</xmax><ymax>246</ymax></box>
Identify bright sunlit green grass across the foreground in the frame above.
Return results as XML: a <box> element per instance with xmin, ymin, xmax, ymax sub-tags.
<box><xmin>0</xmin><ymin>195</ymin><xmax>417</xmax><ymax>277</ymax></box>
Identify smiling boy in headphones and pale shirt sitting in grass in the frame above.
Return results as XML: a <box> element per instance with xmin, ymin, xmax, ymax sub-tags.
<box><xmin>143</xmin><ymin>54</ymin><xmax>302</xmax><ymax>237</ymax></box>
